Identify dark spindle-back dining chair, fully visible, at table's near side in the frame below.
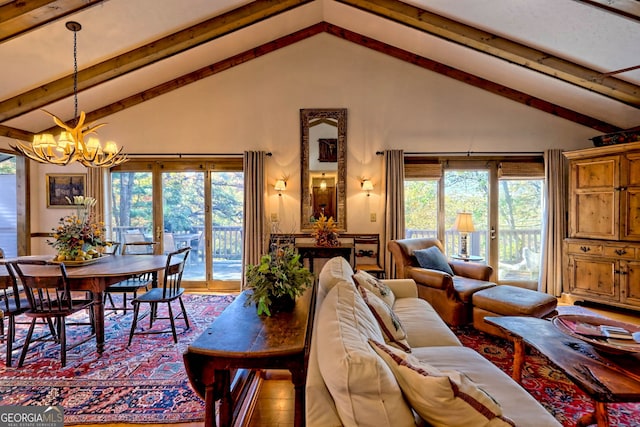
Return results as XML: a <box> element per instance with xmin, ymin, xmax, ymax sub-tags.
<box><xmin>11</xmin><ymin>260</ymin><xmax>95</xmax><ymax>367</ymax></box>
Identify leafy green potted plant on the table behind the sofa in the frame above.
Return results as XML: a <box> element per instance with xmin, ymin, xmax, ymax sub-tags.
<box><xmin>245</xmin><ymin>246</ymin><xmax>313</xmax><ymax>316</ymax></box>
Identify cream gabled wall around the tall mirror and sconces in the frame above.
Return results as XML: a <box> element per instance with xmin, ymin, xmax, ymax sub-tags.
<box><xmin>0</xmin><ymin>34</ymin><xmax>601</xmax><ymax>241</ymax></box>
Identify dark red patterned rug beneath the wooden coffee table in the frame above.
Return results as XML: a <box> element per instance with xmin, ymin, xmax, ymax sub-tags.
<box><xmin>454</xmin><ymin>306</ymin><xmax>640</xmax><ymax>427</ymax></box>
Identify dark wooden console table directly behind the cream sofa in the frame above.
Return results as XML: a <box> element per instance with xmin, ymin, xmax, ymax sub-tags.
<box><xmin>184</xmin><ymin>286</ymin><xmax>315</xmax><ymax>427</ymax></box>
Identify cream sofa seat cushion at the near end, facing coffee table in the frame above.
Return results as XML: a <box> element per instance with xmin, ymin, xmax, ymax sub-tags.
<box><xmin>411</xmin><ymin>347</ymin><xmax>561</xmax><ymax>427</ymax></box>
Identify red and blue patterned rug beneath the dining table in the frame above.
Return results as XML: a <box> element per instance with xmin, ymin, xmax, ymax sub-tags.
<box><xmin>0</xmin><ymin>295</ymin><xmax>234</xmax><ymax>424</ymax></box>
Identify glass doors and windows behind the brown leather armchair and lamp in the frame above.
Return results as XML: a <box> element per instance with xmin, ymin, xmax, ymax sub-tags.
<box><xmin>405</xmin><ymin>157</ymin><xmax>544</xmax><ymax>288</ymax></box>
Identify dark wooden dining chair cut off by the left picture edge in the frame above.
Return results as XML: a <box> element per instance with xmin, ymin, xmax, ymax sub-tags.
<box><xmin>0</xmin><ymin>248</ymin><xmax>29</xmax><ymax>367</ymax></box>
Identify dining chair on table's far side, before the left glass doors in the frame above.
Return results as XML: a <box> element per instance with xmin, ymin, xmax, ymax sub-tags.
<box><xmin>104</xmin><ymin>241</ymin><xmax>158</xmax><ymax>314</ymax></box>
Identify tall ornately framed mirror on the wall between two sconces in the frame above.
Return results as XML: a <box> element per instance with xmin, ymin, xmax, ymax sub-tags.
<box><xmin>300</xmin><ymin>108</ymin><xmax>347</xmax><ymax>231</ymax></box>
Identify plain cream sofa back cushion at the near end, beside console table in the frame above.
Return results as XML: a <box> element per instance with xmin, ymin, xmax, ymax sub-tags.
<box><xmin>314</xmin><ymin>281</ymin><xmax>415</xmax><ymax>427</ymax></box>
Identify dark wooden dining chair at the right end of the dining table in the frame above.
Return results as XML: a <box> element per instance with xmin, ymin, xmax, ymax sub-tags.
<box><xmin>127</xmin><ymin>246</ymin><xmax>191</xmax><ymax>346</ymax></box>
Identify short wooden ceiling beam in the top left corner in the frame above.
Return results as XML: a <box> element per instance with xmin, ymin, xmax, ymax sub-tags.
<box><xmin>0</xmin><ymin>0</ymin><xmax>107</xmax><ymax>43</ymax></box>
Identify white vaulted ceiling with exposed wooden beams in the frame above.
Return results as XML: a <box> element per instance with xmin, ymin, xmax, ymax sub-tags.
<box><xmin>0</xmin><ymin>0</ymin><xmax>640</xmax><ymax>145</ymax></box>
